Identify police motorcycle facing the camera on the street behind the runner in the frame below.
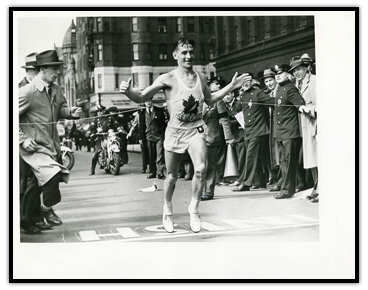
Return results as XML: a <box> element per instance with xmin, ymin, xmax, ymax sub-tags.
<box><xmin>95</xmin><ymin>129</ymin><xmax>124</xmax><ymax>175</ymax></box>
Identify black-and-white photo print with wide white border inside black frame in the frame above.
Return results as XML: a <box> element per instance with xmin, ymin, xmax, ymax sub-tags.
<box><xmin>10</xmin><ymin>9</ymin><xmax>356</xmax><ymax>279</ymax></box>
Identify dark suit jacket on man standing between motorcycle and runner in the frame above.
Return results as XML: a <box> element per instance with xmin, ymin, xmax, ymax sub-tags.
<box><xmin>138</xmin><ymin>106</ymin><xmax>166</xmax><ymax>142</ymax></box>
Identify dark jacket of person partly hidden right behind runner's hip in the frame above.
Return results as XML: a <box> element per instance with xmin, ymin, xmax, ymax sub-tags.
<box><xmin>203</xmin><ymin>100</ymin><xmax>234</xmax><ymax>146</ymax></box>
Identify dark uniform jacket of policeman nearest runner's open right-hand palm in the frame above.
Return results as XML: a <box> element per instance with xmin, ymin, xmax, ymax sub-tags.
<box><xmin>240</xmin><ymin>87</ymin><xmax>274</xmax><ymax>140</ymax></box>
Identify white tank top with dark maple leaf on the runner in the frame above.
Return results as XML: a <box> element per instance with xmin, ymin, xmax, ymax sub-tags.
<box><xmin>167</xmin><ymin>70</ymin><xmax>204</xmax><ymax>129</ymax></box>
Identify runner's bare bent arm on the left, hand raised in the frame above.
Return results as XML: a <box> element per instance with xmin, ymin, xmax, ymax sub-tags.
<box><xmin>120</xmin><ymin>74</ymin><xmax>168</xmax><ymax>103</ymax></box>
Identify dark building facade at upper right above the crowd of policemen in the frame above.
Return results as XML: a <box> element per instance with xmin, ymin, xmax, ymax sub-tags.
<box><xmin>215</xmin><ymin>16</ymin><xmax>315</xmax><ymax>81</ymax></box>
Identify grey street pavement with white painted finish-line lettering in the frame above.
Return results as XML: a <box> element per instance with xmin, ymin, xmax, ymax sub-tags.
<box><xmin>20</xmin><ymin>148</ymin><xmax>319</xmax><ymax>243</ymax></box>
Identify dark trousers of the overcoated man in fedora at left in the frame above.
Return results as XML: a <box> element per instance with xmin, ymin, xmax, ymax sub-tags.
<box><xmin>20</xmin><ymin>171</ymin><xmax>61</xmax><ymax>223</ymax></box>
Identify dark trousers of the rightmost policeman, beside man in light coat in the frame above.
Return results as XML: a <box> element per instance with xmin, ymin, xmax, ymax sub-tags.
<box><xmin>277</xmin><ymin>138</ymin><xmax>301</xmax><ymax>196</ymax></box>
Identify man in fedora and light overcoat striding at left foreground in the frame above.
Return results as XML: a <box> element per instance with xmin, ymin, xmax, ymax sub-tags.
<box><xmin>19</xmin><ymin>50</ymin><xmax>81</xmax><ymax>234</ymax></box>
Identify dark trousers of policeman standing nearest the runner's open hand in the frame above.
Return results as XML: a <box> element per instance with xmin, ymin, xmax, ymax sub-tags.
<box><xmin>240</xmin><ymin>135</ymin><xmax>268</xmax><ymax>186</ymax></box>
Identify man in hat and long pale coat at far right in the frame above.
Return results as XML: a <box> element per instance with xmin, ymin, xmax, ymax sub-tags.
<box><xmin>290</xmin><ymin>54</ymin><xmax>318</xmax><ymax>201</ymax></box>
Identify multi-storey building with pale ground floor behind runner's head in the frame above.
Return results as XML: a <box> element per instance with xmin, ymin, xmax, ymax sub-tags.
<box><xmin>76</xmin><ymin>17</ymin><xmax>215</xmax><ymax>115</ymax></box>
